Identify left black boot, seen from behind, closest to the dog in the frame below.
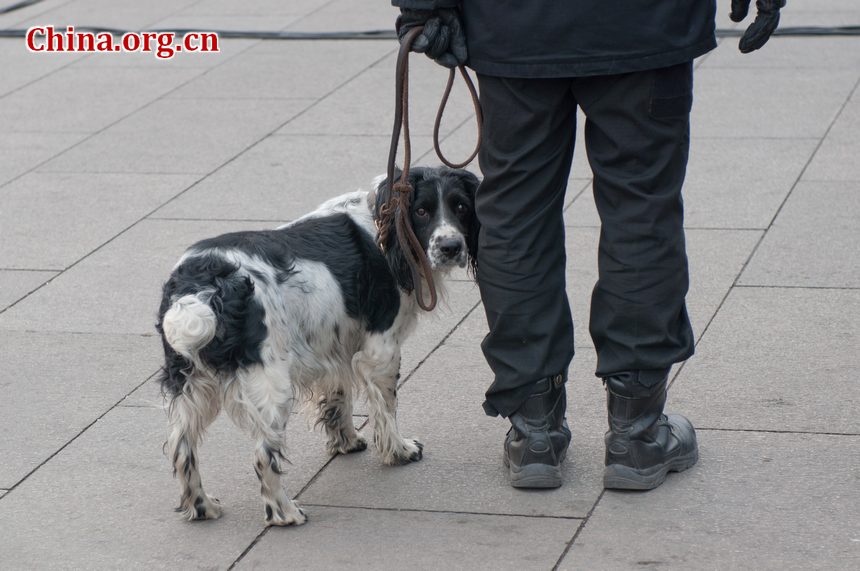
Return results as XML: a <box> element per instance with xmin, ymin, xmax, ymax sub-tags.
<box><xmin>505</xmin><ymin>375</ymin><xmax>570</xmax><ymax>488</ymax></box>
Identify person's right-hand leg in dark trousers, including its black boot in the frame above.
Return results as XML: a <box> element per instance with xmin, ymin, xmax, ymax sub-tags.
<box><xmin>574</xmin><ymin>63</ymin><xmax>697</xmax><ymax>489</ymax></box>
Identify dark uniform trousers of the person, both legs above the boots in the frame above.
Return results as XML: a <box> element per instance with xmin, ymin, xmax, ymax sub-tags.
<box><xmin>476</xmin><ymin>62</ymin><xmax>693</xmax><ymax>417</ymax></box>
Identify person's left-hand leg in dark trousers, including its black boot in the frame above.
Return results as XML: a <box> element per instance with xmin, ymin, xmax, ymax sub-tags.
<box><xmin>476</xmin><ymin>76</ymin><xmax>576</xmax><ymax>487</ymax></box>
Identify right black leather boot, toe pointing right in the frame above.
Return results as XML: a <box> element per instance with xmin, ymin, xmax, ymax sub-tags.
<box><xmin>603</xmin><ymin>371</ymin><xmax>699</xmax><ymax>490</ymax></box>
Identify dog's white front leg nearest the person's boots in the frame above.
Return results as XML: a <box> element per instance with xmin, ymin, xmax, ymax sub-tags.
<box><xmin>352</xmin><ymin>333</ymin><xmax>424</xmax><ymax>464</ymax></box>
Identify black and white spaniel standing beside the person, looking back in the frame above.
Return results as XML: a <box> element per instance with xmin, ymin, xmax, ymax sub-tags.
<box><xmin>157</xmin><ymin>168</ymin><xmax>478</xmax><ymax>525</ymax></box>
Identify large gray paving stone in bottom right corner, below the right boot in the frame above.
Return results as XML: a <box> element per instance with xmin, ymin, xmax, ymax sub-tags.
<box><xmin>560</xmin><ymin>431</ymin><xmax>860</xmax><ymax>571</ymax></box>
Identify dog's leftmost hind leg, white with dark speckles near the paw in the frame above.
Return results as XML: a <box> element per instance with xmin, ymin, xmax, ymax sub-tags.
<box><xmin>167</xmin><ymin>374</ymin><xmax>221</xmax><ymax>520</ymax></box>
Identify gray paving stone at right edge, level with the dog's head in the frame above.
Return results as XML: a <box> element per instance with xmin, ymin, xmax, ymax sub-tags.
<box><xmin>739</xmin><ymin>181</ymin><xmax>860</xmax><ymax>288</ymax></box>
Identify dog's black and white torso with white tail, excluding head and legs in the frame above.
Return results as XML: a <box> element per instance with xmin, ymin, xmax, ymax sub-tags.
<box><xmin>157</xmin><ymin>213</ymin><xmax>400</xmax><ymax>395</ymax></box>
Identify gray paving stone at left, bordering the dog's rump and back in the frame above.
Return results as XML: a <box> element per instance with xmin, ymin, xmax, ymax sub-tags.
<box><xmin>0</xmin><ymin>221</ymin><xmax>269</xmax><ymax>335</ymax></box>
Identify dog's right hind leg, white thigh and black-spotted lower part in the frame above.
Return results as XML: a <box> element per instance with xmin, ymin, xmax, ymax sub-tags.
<box><xmin>228</xmin><ymin>366</ymin><xmax>307</xmax><ymax>526</ymax></box>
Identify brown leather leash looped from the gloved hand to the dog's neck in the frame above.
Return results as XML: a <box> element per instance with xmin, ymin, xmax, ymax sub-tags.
<box><xmin>376</xmin><ymin>27</ymin><xmax>483</xmax><ymax>311</ymax></box>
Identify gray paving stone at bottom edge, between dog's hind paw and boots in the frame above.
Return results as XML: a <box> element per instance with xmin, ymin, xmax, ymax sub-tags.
<box><xmin>236</xmin><ymin>508</ymin><xmax>580</xmax><ymax>570</ymax></box>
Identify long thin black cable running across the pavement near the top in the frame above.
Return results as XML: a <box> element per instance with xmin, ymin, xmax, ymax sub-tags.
<box><xmin>0</xmin><ymin>26</ymin><xmax>860</xmax><ymax>40</ymax></box>
